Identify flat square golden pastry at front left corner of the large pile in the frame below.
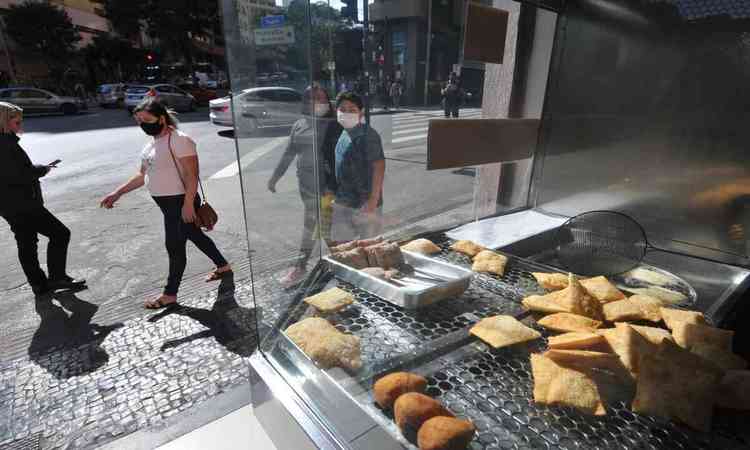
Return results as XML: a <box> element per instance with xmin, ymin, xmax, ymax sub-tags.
<box><xmin>531</xmin><ymin>354</ymin><xmax>606</xmax><ymax>416</ymax></box>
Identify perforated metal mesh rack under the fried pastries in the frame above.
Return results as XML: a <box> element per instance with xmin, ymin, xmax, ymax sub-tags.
<box><xmin>264</xmin><ymin>235</ymin><xmax>750</xmax><ymax>450</ymax></box>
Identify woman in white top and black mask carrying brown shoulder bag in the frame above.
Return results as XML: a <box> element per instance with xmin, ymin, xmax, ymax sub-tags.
<box><xmin>101</xmin><ymin>98</ymin><xmax>232</xmax><ymax>309</ymax></box>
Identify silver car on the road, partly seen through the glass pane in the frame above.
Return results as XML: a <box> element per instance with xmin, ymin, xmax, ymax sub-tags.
<box><xmin>209</xmin><ymin>87</ymin><xmax>302</xmax><ymax>131</ymax></box>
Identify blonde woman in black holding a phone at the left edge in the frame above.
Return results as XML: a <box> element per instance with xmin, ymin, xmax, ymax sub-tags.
<box><xmin>0</xmin><ymin>102</ymin><xmax>86</xmax><ymax>296</ymax></box>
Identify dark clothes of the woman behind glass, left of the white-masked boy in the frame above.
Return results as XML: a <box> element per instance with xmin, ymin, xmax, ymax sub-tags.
<box><xmin>271</xmin><ymin>115</ymin><xmax>343</xmax><ymax>267</ymax></box>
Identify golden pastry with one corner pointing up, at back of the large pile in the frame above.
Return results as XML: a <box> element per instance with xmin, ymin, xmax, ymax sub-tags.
<box><xmin>522</xmin><ymin>274</ymin><xmax>604</xmax><ymax>320</ymax></box>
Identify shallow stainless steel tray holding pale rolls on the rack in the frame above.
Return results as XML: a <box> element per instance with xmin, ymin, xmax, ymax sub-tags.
<box><xmin>323</xmin><ymin>251</ymin><xmax>473</xmax><ymax>309</ymax></box>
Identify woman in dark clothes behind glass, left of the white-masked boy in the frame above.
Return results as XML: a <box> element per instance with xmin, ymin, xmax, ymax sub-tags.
<box><xmin>268</xmin><ymin>86</ymin><xmax>342</xmax><ymax>287</ymax></box>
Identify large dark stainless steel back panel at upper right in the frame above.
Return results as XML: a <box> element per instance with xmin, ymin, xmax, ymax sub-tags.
<box><xmin>532</xmin><ymin>0</ymin><xmax>750</xmax><ymax>265</ymax></box>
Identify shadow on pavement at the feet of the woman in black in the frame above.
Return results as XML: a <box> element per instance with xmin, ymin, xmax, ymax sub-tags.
<box><xmin>29</xmin><ymin>292</ymin><xmax>123</xmax><ymax>379</ymax></box>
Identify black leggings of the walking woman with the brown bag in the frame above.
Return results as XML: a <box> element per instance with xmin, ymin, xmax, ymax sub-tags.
<box><xmin>153</xmin><ymin>195</ymin><xmax>228</xmax><ymax>295</ymax></box>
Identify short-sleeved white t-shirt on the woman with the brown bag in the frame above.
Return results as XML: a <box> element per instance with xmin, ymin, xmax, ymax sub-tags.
<box><xmin>141</xmin><ymin>130</ymin><xmax>198</xmax><ymax>197</ymax></box>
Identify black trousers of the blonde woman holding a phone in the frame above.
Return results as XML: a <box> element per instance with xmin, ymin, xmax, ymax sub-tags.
<box><xmin>3</xmin><ymin>206</ymin><xmax>70</xmax><ymax>287</ymax></box>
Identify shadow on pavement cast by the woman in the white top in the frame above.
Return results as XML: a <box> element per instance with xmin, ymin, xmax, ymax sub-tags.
<box><xmin>148</xmin><ymin>277</ymin><xmax>257</xmax><ymax>357</ymax></box>
